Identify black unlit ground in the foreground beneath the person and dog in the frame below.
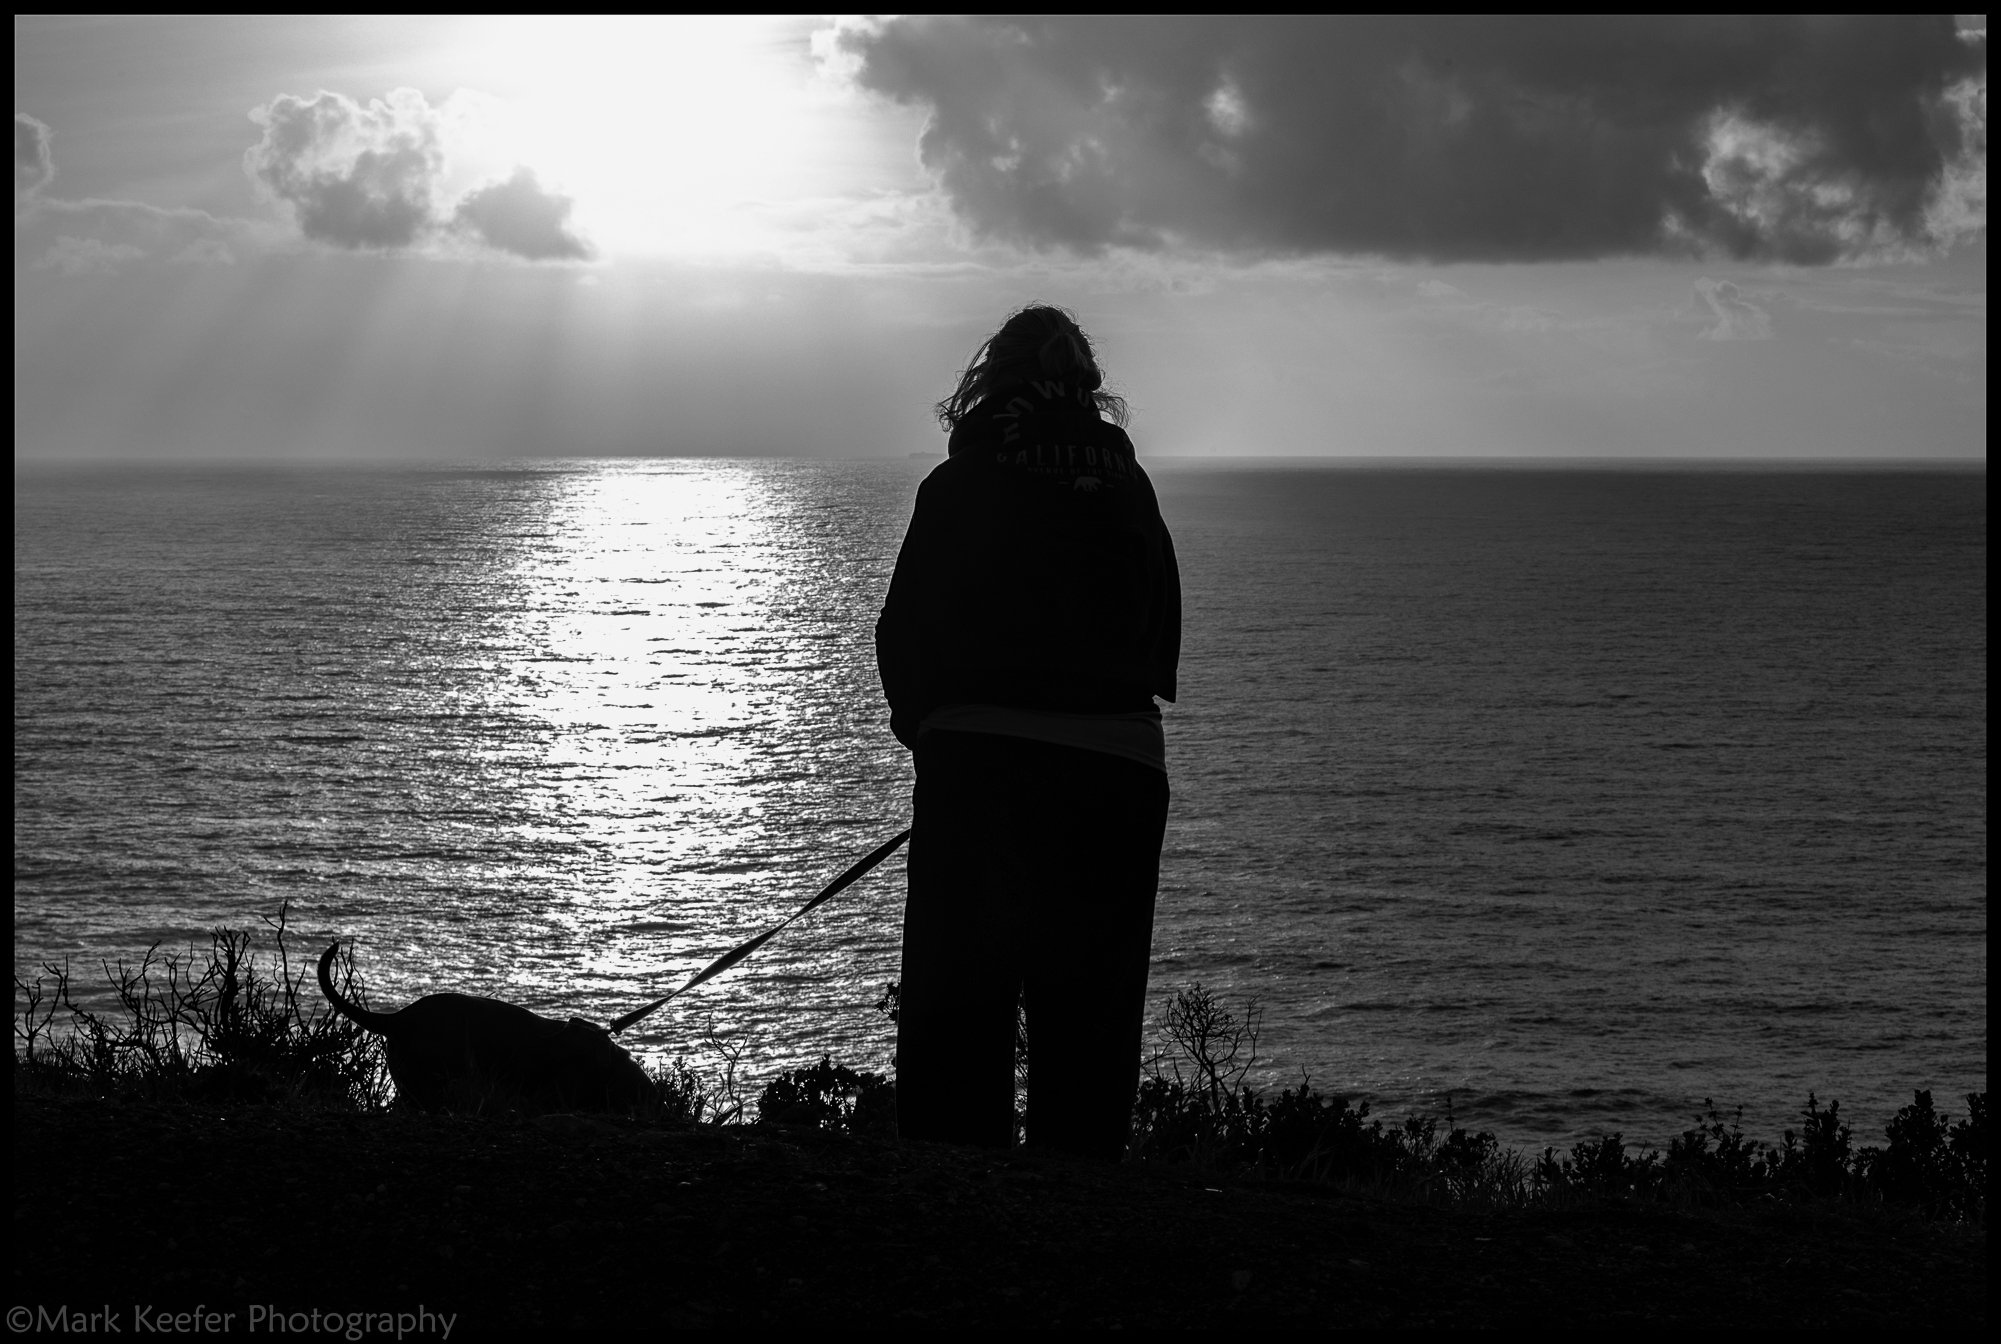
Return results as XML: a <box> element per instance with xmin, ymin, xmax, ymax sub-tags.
<box><xmin>8</xmin><ymin>1096</ymin><xmax>1987</xmax><ymax>1338</ymax></box>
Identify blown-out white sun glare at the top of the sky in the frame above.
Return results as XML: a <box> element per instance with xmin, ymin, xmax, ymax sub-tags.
<box><xmin>460</xmin><ymin>16</ymin><xmax>830</xmax><ymax>254</ymax></box>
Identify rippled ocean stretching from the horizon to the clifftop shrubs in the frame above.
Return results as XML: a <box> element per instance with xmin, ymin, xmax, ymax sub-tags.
<box><xmin>14</xmin><ymin>458</ymin><xmax>1987</xmax><ymax>1148</ymax></box>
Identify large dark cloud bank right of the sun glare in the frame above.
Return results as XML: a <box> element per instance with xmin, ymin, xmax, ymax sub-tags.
<box><xmin>836</xmin><ymin>16</ymin><xmax>1987</xmax><ymax>262</ymax></box>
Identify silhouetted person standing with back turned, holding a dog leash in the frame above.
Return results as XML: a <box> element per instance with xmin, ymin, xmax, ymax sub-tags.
<box><xmin>876</xmin><ymin>306</ymin><xmax>1181</xmax><ymax>1158</ymax></box>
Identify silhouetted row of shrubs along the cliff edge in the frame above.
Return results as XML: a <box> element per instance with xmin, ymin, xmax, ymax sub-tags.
<box><xmin>14</xmin><ymin>924</ymin><xmax>1987</xmax><ymax>1226</ymax></box>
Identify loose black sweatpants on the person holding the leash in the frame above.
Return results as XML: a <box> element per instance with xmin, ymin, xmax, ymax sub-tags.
<box><xmin>896</xmin><ymin>732</ymin><xmax>1167</xmax><ymax>1160</ymax></box>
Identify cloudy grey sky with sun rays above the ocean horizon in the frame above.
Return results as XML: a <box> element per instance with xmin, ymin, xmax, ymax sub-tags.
<box><xmin>14</xmin><ymin>16</ymin><xmax>1987</xmax><ymax>464</ymax></box>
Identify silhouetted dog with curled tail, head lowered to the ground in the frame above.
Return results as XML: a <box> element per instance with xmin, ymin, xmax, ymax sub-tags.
<box><xmin>320</xmin><ymin>942</ymin><xmax>654</xmax><ymax>1110</ymax></box>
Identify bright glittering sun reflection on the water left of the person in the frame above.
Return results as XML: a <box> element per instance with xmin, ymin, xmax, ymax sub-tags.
<box><xmin>464</xmin><ymin>462</ymin><xmax>912</xmax><ymax>1052</ymax></box>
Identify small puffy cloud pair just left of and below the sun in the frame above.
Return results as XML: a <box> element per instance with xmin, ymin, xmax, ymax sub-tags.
<box><xmin>244</xmin><ymin>88</ymin><xmax>592</xmax><ymax>262</ymax></box>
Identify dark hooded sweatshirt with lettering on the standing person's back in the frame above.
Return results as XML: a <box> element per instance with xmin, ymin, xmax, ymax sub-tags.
<box><xmin>876</xmin><ymin>380</ymin><xmax>1181</xmax><ymax>748</ymax></box>
